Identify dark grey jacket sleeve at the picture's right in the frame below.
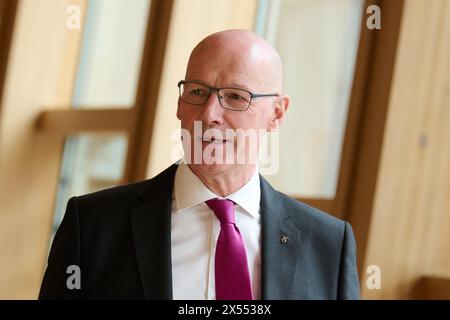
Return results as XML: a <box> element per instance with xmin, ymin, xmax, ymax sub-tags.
<box><xmin>337</xmin><ymin>222</ymin><xmax>359</xmax><ymax>300</ymax></box>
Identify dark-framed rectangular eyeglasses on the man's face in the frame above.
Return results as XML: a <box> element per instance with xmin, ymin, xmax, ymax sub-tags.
<box><xmin>178</xmin><ymin>80</ymin><xmax>279</xmax><ymax>111</ymax></box>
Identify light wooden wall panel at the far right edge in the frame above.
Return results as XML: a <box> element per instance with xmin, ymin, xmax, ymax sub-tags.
<box><xmin>361</xmin><ymin>0</ymin><xmax>450</xmax><ymax>299</ymax></box>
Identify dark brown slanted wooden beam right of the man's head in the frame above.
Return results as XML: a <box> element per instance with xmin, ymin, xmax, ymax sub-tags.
<box><xmin>344</xmin><ymin>0</ymin><xmax>403</xmax><ymax>283</ymax></box>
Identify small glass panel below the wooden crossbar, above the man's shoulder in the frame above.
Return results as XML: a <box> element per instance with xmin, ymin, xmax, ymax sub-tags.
<box><xmin>52</xmin><ymin>134</ymin><xmax>128</xmax><ymax>238</ymax></box>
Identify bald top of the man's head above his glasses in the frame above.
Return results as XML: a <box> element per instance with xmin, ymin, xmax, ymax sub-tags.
<box><xmin>186</xmin><ymin>29</ymin><xmax>283</xmax><ymax>93</ymax></box>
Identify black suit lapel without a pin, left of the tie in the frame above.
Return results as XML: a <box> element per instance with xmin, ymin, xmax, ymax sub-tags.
<box><xmin>131</xmin><ymin>165</ymin><xmax>177</xmax><ymax>300</ymax></box>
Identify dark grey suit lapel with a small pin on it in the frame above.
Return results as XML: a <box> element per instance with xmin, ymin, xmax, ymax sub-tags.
<box><xmin>260</xmin><ymin>177</ymin><xmax>300</xmax><ymax>300</ymax></box>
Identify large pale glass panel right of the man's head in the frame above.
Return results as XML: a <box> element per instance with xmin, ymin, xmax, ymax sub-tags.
<box><xmin>255</xmin><ymin>0</ymin><xmax>364</xmax><ymax>198</ymax></box>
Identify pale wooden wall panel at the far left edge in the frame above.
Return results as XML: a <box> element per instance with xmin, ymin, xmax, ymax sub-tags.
<box><xmin>0</xmin><ymin>0</ymin><xmax>86</xmax><ymax>299</ymax></box>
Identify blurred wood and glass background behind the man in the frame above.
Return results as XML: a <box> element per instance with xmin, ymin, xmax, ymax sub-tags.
<box><xmin>0</xmin><ymin>0</ymin><xmax>450</xmax><ymax>299</ymax></box>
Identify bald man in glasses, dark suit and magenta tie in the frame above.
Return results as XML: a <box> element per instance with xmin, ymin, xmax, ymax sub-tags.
<box><xmin>40</xmin><ymin>30</ymin><xmax>359</xmax><ymax>299</ymax></box>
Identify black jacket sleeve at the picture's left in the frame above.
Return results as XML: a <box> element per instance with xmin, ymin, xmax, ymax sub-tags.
<box><xmin>39</xmin><ymin>197</ymin><xmax>82</xmax><ymax>300</ymax></box>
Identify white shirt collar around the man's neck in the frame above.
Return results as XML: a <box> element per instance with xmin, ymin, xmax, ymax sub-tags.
<box><xmin>174</xmin><ymin>161</ymin><xmax>261</xmax><ymax>218</ymax></box>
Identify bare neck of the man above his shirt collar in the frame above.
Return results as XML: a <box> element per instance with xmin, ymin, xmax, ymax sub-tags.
<box><xmin>189</xmin><ymin>165</ymin><xmax>256</xmax><ymax>197</ymax></box>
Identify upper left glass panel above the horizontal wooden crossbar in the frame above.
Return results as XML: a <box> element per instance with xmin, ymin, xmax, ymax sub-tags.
<box><xmin>72</xmin><ymin>0</ymin><xmax>150</xmax><ymax>108</ymax></box>
